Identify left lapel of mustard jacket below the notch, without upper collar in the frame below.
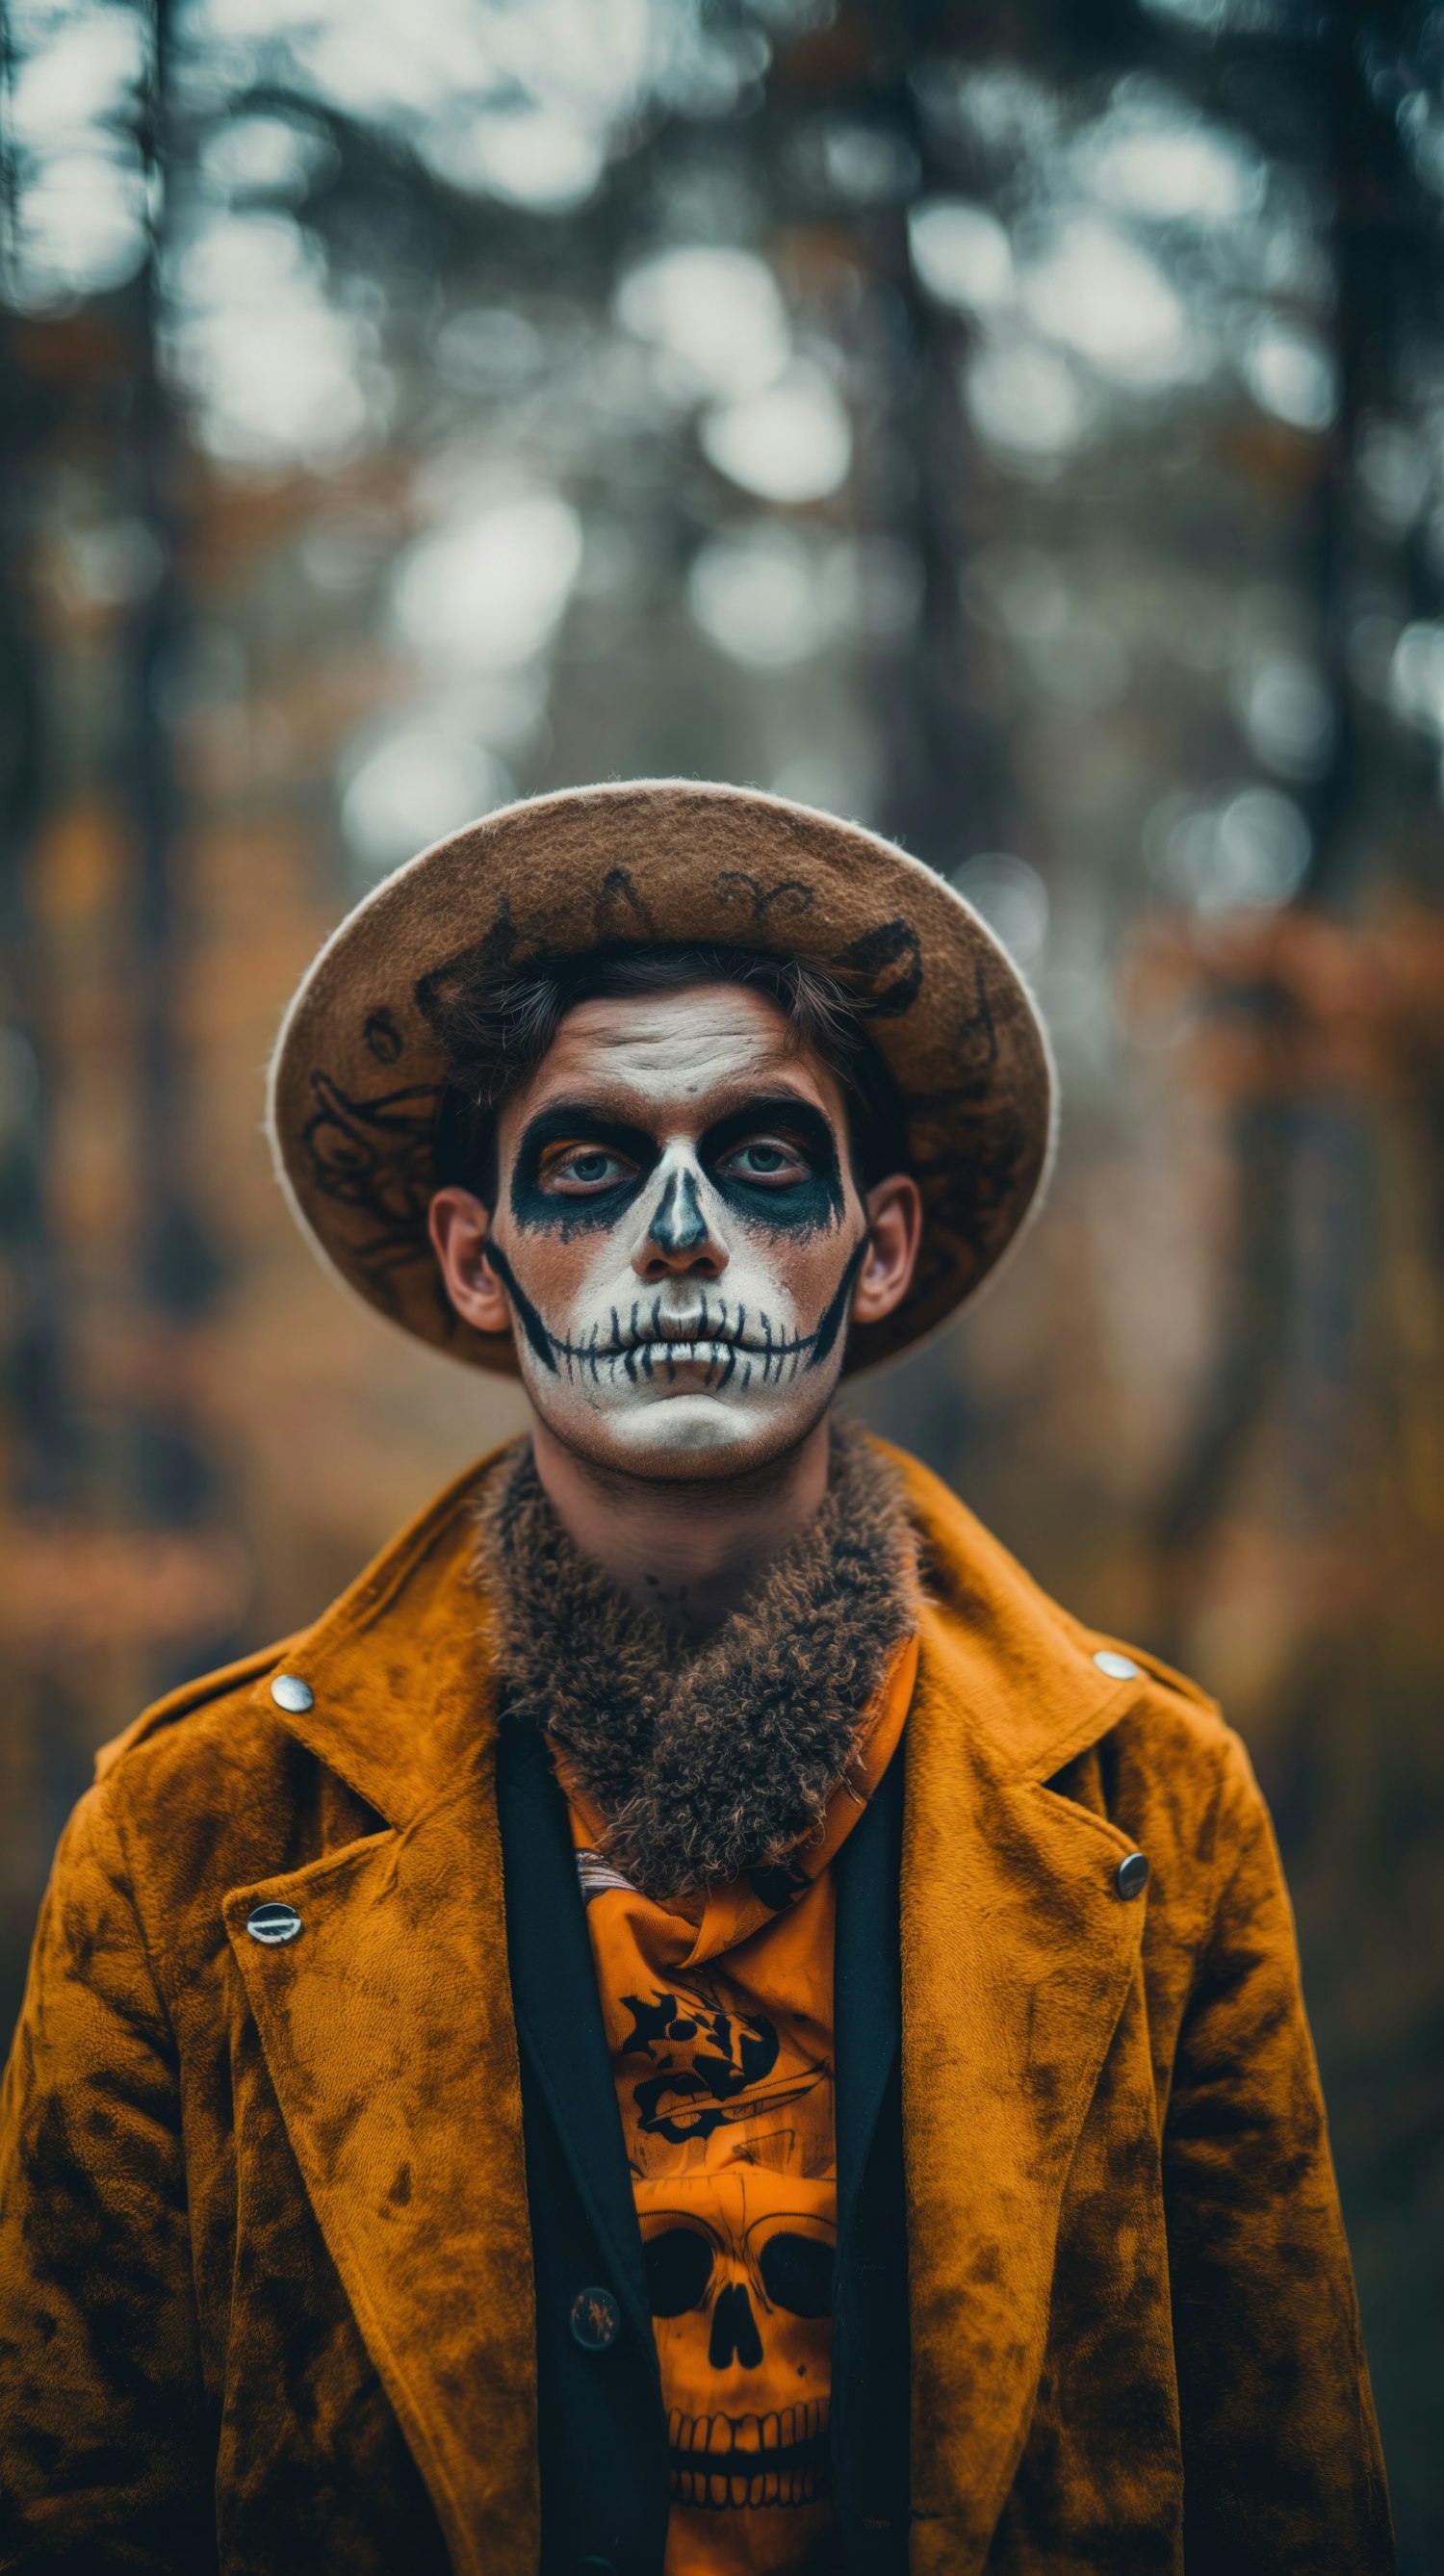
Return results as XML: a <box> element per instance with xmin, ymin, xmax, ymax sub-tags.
<box><xmin>226</xmin><ymin>1777</ymin><xmax>538</xmax><ymax>2576</ymax></box>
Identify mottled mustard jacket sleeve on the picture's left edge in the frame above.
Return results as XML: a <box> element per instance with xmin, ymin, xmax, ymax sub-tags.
<box><xmin>0</xmin><ymin>1785</ymin><xmax>217</xmax><ymax>2576</ymax></box>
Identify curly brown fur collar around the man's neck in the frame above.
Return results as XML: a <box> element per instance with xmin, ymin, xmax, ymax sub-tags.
<box><xmin>478</xmin><ymin>1425</ymin><xmax>919</xmax><ymax>1896</ymax></box>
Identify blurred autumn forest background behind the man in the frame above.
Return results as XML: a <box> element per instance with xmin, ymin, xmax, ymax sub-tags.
<box><xmin>0</xmin><ymin>0</ymin><xmax>1444</xmax><ymax>2576</ymax></box>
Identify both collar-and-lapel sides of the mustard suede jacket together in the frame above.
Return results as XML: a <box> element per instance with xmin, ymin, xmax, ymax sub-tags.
<box><xmin>226</xmin><ymin>1453</ymin><xmax>1146</xmax><ymax>2576</ymax></box>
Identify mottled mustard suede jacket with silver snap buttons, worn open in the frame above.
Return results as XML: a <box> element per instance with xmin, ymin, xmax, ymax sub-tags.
<box><xmin>0</xmin><ymin>1460</ymin><xmax>1393</xmax><ymax>2576</ymax></box>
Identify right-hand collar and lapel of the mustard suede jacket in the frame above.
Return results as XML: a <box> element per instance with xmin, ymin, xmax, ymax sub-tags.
<box><xmin>901</xmin><ymin>1463</ymin><xmax>1146</xmax><ymax>2576</ymax></box>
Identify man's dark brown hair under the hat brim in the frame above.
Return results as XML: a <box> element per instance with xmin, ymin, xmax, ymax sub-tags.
<box><xmin>425</xmin><ymin>942</ymin><xmax>906</xmax><ymax>1205</ymax></box>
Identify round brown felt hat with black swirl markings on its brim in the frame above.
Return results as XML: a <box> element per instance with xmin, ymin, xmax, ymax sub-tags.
<box><xmin>268</xmin><ymin>778</ymin><xmax>1053</xmax><ymax>1373</ymax></box>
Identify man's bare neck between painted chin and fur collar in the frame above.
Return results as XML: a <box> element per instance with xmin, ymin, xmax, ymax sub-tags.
<box><xmin>532</xmin><ymin>1417</ymin><xmax>829</xmax><ymax>1641</ymax></box>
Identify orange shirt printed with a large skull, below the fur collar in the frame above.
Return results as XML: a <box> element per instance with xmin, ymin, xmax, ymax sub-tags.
<box><xmin>558</xmin><ymin>1636</ymin><xmax>919</xmax><ymax>2576</ymax></box>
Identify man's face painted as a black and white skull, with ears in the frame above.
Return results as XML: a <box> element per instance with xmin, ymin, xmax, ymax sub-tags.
<box><xmin>432</xmin><ymin>984</ymin><xmax>916</xmax><ymax>1476</ymax></box>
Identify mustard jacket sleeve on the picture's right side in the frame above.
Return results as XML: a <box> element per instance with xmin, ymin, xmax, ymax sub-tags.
<box><xmin>1164</xmin><ymin>1737</ymin><xmax>1393</xmax><ymax>2576</ymax></box>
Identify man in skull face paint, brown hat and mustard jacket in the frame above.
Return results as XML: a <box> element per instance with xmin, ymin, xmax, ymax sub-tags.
<box><xmin>0</xmin><ymin>784</ymin><xmax>1390</xmax><ymax>2576</ymax></box>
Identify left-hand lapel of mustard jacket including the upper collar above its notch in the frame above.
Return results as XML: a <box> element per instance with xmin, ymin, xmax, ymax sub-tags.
<box><xmin>224</xmin><ymin>1476</ymin><xmax>540</xmax><ymax>2576</ymax></box>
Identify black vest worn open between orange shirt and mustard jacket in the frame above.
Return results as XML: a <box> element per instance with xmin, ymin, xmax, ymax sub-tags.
<box><xmin>497</xmin><ymin>1723</ymin><xmax>909</xmax><ymax>2576</ymax></box>
